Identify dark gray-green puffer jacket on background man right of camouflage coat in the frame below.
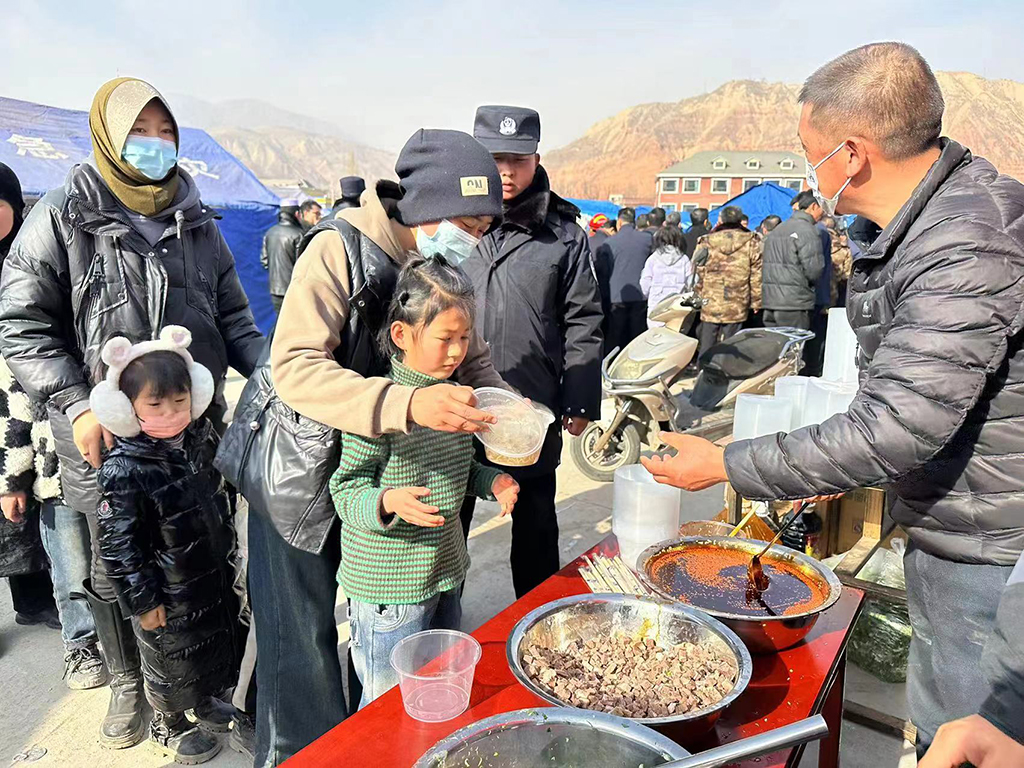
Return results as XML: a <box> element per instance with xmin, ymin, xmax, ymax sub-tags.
<box><xmin>761</xmin><ymin>211</ymin><xmax>825</xmax><ymax>309</ymax></box>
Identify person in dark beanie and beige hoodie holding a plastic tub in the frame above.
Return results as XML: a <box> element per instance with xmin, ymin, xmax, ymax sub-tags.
<box><xmin>243</xmin><ymin>130</ymin><xmax>506</xmax><ymax>768</ymax></box>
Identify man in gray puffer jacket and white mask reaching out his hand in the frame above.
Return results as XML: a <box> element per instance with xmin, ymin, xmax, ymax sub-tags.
<box><xmin>645</xmin><ymin>43</ymin><xmax>1024</xmax><ymax>753</ymax></box>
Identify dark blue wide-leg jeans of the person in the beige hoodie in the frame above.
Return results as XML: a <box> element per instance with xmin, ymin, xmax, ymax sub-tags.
<box><xmin>249</xmin><ymin>509</ymin><xmax>346</xmax><ymax>768</ymax></box>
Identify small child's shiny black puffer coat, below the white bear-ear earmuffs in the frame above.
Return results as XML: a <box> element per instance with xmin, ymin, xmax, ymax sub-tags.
<box><xmin>96</xmin><ymin>419</ymin><xmax>238</xmax><ymax>712</ymax></box>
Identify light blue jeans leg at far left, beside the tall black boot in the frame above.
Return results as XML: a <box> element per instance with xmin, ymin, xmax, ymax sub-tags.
<box><xmin>39</xmin><ymin>502</ymin><xmax>96</xmax><ymax>650</ymax></box>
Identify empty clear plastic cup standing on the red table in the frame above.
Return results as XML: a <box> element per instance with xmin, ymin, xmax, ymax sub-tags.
<box><xmin>391</xmin><ymin>630</ymin><xmax>482</xmax><ymax>723</ymax></box>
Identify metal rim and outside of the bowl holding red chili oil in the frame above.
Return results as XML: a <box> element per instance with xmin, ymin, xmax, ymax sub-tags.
<box><xmin>637</xmin><ymin>536</ymin><xmax>843</xmax><ymax>653</ymax></box>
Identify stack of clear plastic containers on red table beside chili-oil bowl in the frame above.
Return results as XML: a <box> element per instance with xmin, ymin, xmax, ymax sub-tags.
<box><xmin>611</xmin><ymin>464</ymin><xmax>682</xmax><ymax>570</ymax></box>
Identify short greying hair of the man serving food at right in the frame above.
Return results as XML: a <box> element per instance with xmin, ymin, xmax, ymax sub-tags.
<box><xmin>800</xmin><ymin>43</ymin><xmax>945</xmax><ymax>161</ymax></box>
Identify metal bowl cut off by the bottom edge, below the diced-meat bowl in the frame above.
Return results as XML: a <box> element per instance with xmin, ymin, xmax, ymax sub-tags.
<box><xmin>413</xmin><ymin>707</ymin><xmax>689</xmax><ymax>768</ymax></box>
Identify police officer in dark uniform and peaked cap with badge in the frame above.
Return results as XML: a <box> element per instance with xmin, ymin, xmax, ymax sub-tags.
<box><xmin>463</xmin><ymin>106</ymin><xmax>602</xmax><ymax>597</ymax></box>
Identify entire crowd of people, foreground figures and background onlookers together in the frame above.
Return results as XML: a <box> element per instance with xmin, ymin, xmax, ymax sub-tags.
<box><xmin>0</xmin><ymin>44</ymin><xmax>1024</xmax><ymax>768</ymax></box>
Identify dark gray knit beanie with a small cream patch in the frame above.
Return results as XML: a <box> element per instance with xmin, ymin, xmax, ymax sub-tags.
<box><xmin>394</xmin><ymin>128</ymin><xmax>502</xmax><ymax>226</ymax></box>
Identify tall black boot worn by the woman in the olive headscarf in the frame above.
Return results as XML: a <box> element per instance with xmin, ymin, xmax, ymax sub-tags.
<box><xmin>85</xmin><ymin>581</ymin><xmax>145</xmax><ymax>750</ymax></box>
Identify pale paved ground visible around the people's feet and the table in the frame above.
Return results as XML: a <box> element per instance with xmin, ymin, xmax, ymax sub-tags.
<box><xmin>0</xmin><ymin>382</ymin><xmax>915</xmax><ymax>768</ymax></box>
